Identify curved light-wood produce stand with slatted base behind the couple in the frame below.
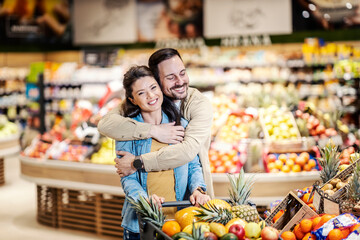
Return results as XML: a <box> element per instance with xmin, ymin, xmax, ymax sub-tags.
<box><xmin>20</xmin><ymin>155</ymin><xmax>319</xmax><ymax>237</ymax></box>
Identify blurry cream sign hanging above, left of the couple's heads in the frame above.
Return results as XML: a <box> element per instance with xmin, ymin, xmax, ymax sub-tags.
<box><xmin>74</xmin><ymin>0</ymin><xmax>137</xmax><ymax>45</ymax></box>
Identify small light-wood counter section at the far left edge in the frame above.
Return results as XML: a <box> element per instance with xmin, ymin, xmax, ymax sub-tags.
<box><xmin>0</xmin><ymin>134</ymin><xmax>20</xmax><ymax>185</ymax></box>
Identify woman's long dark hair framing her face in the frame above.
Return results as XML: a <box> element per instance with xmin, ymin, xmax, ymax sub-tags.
<box><xmin>122</xmin><ymin>66</ymin><xmax>181</xmax><ymax>125</ymax></box>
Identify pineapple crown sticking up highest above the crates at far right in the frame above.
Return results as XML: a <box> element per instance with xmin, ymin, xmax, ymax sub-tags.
<box><xmin>319</xmin><ymin>142</ymin><xmax>340</xmax><ymax>183</ymax></box>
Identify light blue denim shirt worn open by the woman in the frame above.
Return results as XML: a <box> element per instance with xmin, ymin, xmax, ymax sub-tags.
<box><xmin>116</xmin><ymin>112</ymin><xmax>206</xmax><ymax>233</ymax></box>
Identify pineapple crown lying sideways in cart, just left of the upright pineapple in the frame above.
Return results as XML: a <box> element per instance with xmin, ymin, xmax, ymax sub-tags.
<box><xmin>195</xmin><ymin>201</ymin><xmax>233</xmax><ymax>225</ymax></box>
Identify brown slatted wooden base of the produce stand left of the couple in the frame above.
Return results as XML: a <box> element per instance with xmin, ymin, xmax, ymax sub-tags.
<box><xmin>37</xmin><ymin>186</ymin><xmax>125</xmax><ymax>239</ymax></box>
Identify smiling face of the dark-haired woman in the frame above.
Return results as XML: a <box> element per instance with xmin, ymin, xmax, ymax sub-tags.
<box><xmin>130</xmin><ymin>76</ymin><xmax>163</xmax><ymax>112</ymax></box>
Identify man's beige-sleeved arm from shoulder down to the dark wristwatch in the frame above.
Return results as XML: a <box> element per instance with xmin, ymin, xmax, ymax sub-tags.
<box><xmin>141</xmin><ymin>89</ymin><xmax>213</xmax><ymax>172</ymax></box>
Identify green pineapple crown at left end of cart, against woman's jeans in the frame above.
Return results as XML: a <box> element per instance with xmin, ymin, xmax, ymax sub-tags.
<box><xmin>126</xmin><ymin>195</ymin><xmax>165</xmax><ymax>229</ymax></box>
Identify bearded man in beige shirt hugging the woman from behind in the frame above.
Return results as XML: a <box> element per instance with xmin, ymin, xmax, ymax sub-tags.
<box><xmin>98</xmin><ymin>48</ymin><xmax>214</xmax><ymax>198</ymax></box>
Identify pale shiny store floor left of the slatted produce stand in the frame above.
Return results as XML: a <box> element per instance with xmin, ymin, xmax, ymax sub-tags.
<box><xmin>0</xmin><ymin>157</ymin><xmax>107</xmax><ymax>240</ymax></box>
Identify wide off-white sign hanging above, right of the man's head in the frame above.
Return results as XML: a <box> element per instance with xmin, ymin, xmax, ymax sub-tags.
<box><xmin>204</xmin><ymin>0</ymin><xmax>292</xmax><ymax>38</ymax></box>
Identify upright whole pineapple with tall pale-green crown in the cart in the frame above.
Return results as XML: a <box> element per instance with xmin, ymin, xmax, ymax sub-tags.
<box><xmin>227</xmin><ymin>169</ymin><xmax>260</xmax><ymax>222</ymax></box>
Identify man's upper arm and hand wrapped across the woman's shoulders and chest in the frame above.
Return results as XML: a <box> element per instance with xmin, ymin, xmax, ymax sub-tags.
<box><xmin>97</xmin><ymin>105</ymin><xmax>184</xmax><ymax>144</ymax></box>
